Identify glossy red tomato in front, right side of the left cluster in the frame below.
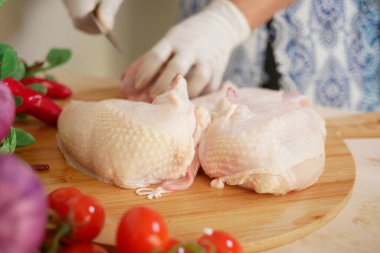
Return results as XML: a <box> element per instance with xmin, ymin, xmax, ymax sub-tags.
<box><xmin>66</xmin><ymin>195</ymin><xmax>105</xmax><ymax>242</ymax></box>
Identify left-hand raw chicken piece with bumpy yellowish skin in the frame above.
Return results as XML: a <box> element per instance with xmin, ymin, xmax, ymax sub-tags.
<box><xmin>58</xmin><ymin>76</ymin><xmax>209</xmax><ymax>197</ymax></box>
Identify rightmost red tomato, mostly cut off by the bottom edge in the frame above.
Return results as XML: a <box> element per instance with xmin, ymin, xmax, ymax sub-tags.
<box><xmin>198</xmin><ymin>229</ymin><xmax>243</xmax><ymax>253</ymax></box>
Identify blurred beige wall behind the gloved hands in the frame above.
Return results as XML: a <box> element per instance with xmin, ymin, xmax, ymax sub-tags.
<box><xmin>0</xmin><ymin>0</ymin><xmax>178</xmax><ymax>80</ymax></box>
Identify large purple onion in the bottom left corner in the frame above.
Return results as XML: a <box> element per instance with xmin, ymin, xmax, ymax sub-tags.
<box><xmin>0</xmin><ymin>155</ymin><xmax>47</xmax><ymax>253</ymax></box>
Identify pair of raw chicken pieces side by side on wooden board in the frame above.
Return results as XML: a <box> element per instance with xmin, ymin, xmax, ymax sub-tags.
<box><xmin>58</xmin><ymin>76</ymin><xmax>325</xmax><ymax>198</ymax></box>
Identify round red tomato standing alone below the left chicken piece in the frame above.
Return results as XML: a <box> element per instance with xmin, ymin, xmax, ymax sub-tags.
<box><xmin>116</xmin><ymin>206</ymin><xmax>169</xmax><ymax>253</ymax></box>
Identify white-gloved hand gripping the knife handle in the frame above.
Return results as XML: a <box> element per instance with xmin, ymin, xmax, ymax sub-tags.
<box><xmin>63</xmin><ymin>0</ymin><xmax>123</xmax><ymax>34</ymax></box>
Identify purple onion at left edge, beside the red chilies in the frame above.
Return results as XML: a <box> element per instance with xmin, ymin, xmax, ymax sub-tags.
<box><xmin>0</xmin><ymin>81</ymin><xmax>16</xmax><ymax>139</ymax></box>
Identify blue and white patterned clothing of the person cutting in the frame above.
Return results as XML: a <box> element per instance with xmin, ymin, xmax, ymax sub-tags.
<box><xmin>179</xmin><ymin>0</ymin><xmax>380</xmax><ymax>111</ymax></box>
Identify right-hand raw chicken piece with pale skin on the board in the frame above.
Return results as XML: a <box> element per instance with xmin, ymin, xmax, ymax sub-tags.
<box><xmin>193</xmin><ymin>84</ymin><xmax>326</xmax><ymax>194</ymax></box>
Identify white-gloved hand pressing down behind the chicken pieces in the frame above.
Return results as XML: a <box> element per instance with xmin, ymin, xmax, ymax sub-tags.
<box><xmin>122</xmin><ymin>0</ymin><xmax>250</xmax><ymax>99</ymax></box>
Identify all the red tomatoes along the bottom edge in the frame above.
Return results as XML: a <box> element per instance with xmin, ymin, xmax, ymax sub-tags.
<box><xmin>41</xmin><ymin>187</ymin><xmax>243</xmax><ymax>253</ymax></box>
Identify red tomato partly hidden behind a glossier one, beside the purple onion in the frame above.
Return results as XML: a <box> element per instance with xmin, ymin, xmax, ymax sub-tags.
<box><xmin>47</xmin><ymin>187</ymin><xmax>83</xmax><ymax>219</ymax></box>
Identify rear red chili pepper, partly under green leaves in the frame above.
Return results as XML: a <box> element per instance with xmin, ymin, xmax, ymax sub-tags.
<box><xmin>21</xmin><ymin>77</ymin><xmax>73</xmax><ymax>99</ymax></box>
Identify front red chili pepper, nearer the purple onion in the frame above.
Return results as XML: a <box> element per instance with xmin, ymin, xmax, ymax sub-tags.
<box><xmin>2</xmin><ymin>77</ymin><xmax>62</xmax><ymax>126</ymax></box>
